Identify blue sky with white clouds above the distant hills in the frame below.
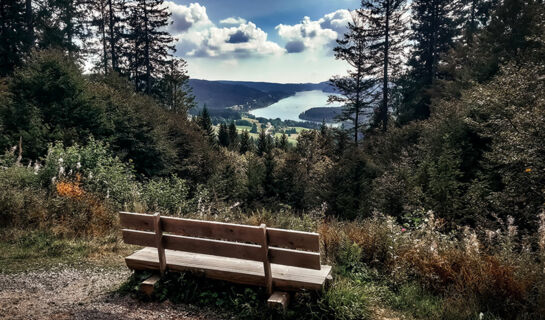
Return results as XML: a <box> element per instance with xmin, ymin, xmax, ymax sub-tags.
<box><xmin>165</xmin><ymin>0</ymin><xmax>360</xmax><ymax>83</ymax></box>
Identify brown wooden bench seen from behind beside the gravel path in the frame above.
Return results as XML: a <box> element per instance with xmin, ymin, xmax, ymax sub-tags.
<box><xmin>120</xmin><ymin>212</ymin><xmax>331</xmax><ymax>308</ymax></box>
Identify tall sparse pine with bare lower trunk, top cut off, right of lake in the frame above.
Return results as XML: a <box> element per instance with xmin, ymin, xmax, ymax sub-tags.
<box><xmin>358</xmin><ymin>0</ymin><xmax>408</xmax><ymax>130</ymax></box>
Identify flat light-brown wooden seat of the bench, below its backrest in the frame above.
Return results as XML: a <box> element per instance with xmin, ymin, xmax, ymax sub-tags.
<box><xmin>125</xmin><ymin>247</ymin><xmax>331</xmax><ymax>291</ymax></box>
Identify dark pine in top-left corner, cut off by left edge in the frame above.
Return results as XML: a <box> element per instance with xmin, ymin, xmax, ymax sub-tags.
<box><xmin>0</xmin><ymin>0</ymin><xmax>29</xmax><ymax>77</ymax></box>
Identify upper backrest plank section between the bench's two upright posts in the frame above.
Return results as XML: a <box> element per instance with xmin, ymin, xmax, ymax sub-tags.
<box><xmin>161</xmin><ymin>217</ymin><xmax>262</xmax><ymax>244</ymax></box>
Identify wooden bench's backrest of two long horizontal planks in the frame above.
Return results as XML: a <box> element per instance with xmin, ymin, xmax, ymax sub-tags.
<box><xmin>120</xmin><ymin>212</ymin><xmax>320</xmax><ymax>272</ymax></box>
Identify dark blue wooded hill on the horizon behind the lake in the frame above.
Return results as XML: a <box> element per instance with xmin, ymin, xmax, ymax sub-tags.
<box><xmin>189</xmin><ymin>79</ymin><xmax>332</xmax><ymax>112</ymax></box>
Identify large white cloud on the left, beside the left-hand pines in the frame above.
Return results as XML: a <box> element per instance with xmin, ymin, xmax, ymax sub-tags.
<box><xmin>168</xmin><ymin>2</ymin><xmax>285</xmax><ymax>58</ymax></box>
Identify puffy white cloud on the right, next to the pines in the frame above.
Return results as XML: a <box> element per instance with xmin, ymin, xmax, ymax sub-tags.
<box><xmin>275</xmin><ymin>10</ymin><xmax>351</xmax><ymax>53</ymax></box>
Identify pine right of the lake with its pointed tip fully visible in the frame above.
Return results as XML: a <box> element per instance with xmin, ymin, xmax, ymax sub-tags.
<box><xmin>328</xmin><ymin>14</ymin><xmax>375</xmax><ymax>144</ymax></box>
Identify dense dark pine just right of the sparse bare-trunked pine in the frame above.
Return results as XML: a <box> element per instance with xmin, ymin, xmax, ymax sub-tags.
<box><xmin>398</xmin><ymin>0</ymin><xmax>464</xmax><ymax>123</ymax></box>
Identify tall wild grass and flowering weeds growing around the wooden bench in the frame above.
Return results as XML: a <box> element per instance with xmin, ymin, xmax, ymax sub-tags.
<box><xmin>0</xmin><ymin>156</ymin><xmax>545</xmax><ymax>319</ymax></box>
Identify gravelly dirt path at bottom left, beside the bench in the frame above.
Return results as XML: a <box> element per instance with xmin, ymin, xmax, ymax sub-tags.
<box><xmin>0</xmin><ymin>266</ymin><xmax>224</xmax><ymax>320</ymax></box>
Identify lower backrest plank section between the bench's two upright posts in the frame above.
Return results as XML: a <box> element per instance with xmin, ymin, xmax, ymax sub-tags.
<box><xmin>163</xmin><ymin>235</ymin><xmax>263</xmax><ymax>261</ymax></box>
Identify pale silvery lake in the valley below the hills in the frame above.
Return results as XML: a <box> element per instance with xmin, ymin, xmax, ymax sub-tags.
<box><xmin>250</xmin><ymin>90</ymin><xmax>340</xmax><ymax>121</ymax></box>
